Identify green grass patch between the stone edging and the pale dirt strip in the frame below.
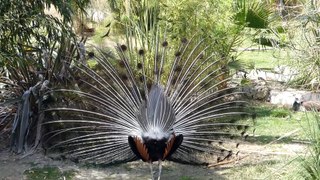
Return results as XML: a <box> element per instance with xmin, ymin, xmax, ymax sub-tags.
<box><xmin>242</xmin><ymin>105</ymin><xmax>318</xmax><ymax>144</ymax></box>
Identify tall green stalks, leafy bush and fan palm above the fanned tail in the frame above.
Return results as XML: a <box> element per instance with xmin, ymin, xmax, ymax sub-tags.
<box><xmin>104</xmin><ymin>0</ymin><xmax>271</xmax><ymax>83</ymax></box>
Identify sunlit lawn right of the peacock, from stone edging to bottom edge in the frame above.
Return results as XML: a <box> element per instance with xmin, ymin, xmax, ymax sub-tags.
<box><xmin>218</xmin><ymin>104</ymin><xmax>315</xmax><ymax>180</ymax></box>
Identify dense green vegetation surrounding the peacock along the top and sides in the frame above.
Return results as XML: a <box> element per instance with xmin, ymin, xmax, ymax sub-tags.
<box><xmin>0</xmin><ymin>0</ymin><xmax>320</xmax><ymax>179</ymax></box>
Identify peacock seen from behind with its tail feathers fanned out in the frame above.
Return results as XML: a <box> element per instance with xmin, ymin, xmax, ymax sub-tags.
<box><xmin>43</xmin><ymin>35</ymin><xmax>249</xmax><ymax>179</ymax></box>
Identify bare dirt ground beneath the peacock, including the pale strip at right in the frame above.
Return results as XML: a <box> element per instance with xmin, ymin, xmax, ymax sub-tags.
<box><xmin>0</xmin><ymin>143</ymin><xmax>307</xmax><ymax>180</ymax></box>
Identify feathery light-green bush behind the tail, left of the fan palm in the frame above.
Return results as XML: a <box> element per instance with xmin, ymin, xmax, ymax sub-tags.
<box><xmin>161</xmin><ymin>0</ymin><xmax>243</xmax><ymax>58</ymax></box>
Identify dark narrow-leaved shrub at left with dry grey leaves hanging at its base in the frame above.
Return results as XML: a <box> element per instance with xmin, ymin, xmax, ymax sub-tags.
<box><xmin>0</xmin><ymin>0</ymin><xmax>89</xmax><ymax>153</ymax></box>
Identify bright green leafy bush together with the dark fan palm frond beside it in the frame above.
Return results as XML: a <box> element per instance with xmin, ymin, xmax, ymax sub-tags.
<box><xmin>161</xmin><ymin>0</ymin><xmax>271</xmax><ymax>66</ymax></box>
